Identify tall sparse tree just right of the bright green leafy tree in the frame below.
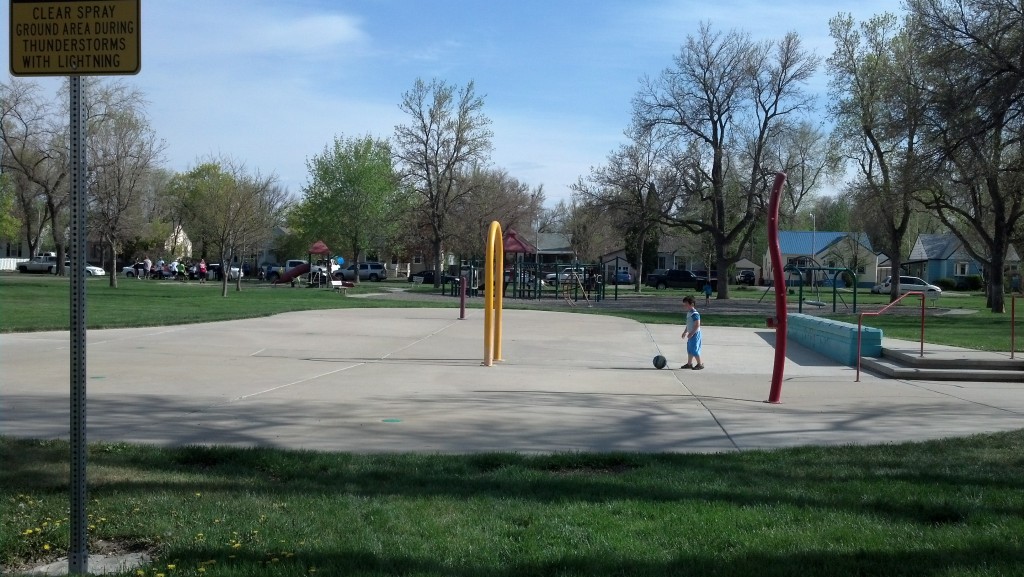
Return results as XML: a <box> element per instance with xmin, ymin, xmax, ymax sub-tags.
<box><xmin>394</xmin><ymin>79</ymin><xmax>492</xmax><ymax>286</ymax></box>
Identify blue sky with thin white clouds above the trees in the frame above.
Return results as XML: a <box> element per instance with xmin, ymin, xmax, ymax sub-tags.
<box><xmin>6</xmin><ymin>0</ymin><xmax>900</xmax><ymax>207</ymax></box>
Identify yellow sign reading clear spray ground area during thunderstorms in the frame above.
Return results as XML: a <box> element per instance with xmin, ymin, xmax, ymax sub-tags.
<box><xmin>10</xmin><ymin>0</ymin><xmax>141</xmax><ymax>76</ymax></box>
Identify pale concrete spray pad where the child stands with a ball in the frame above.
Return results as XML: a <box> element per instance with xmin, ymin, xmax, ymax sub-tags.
<box><xmin>0</xmin><ymin>308</ymin><xmax>1024</xmax><ymax>453</ymax></box>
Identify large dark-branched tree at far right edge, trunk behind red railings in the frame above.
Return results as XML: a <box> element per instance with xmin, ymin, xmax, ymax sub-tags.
<box><xmin>908</xmin><ymin>0</ymin><xmax>1024</xmax><ymax>313</ymax></box>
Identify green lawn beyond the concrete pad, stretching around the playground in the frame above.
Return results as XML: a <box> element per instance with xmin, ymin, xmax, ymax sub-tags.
<box><xmin>0</xmin><ymin>274</ymin><xmax>1024</xmax><ymax>352</ymax></box>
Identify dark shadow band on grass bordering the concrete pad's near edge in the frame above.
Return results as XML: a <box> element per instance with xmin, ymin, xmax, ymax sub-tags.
<box><xmin>0</xmin><ymin>431</ymin><xmax>1024</xmax><ymax>527</ymax></box>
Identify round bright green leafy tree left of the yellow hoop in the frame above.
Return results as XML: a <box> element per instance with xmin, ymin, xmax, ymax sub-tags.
<box><xmin>295</xmin><ymin>135</ymin><xmax>397</xmax><ymax>279</ymax></box>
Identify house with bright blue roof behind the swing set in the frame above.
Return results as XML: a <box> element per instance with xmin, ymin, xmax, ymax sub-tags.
<box><xmin>762</xmin><ymin>231</ymin><xmax>879</xmax><ymax>287</ymax></box>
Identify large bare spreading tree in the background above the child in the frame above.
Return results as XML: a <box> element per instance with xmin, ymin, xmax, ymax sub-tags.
<box><xmin>634</xmin><ymin>24</ymin><xmax>818</xmax><ymax>298</ymax></box>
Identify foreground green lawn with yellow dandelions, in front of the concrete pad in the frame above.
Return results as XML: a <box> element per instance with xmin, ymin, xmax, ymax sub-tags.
<box><xmin>6</xmin><ymin>431</ymin><xmax>1024</xmax><ymax>577</ymax></box>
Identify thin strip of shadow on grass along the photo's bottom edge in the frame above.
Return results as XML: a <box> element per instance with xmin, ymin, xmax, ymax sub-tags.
<box><xmin>153</xmin><ymin>542</ymin><xmax>1024</xmax><ymax>577</ymax></box>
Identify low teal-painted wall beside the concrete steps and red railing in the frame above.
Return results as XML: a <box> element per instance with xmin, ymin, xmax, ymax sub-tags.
<box><xmin>786</xmin><ymin>314</ymin><xmax>882</xmax><ymax>367</ymax></box>
